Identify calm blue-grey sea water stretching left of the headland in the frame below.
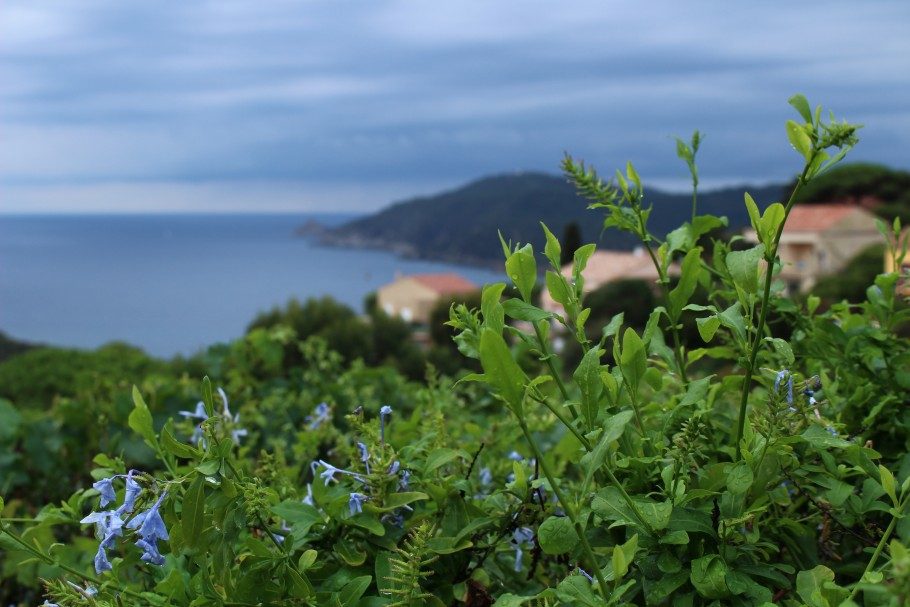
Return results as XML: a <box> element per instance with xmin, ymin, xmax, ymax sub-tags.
<box><xmin>0</xmin><ymin>215</ymin><xmax>501</xmax><ymax>356</ymax></box>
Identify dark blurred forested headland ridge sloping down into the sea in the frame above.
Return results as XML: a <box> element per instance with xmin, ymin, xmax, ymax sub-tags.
<box><xmin>320</xmin><ymin>173</ymin><xmax>785</xmax><ymax>265</ymax></box>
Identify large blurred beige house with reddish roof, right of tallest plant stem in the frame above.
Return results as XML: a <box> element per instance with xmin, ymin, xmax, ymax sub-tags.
<box><xmin>743</xmin><ymin>204</ymin><xmax>881</xmax><ymax>293</ymax></box>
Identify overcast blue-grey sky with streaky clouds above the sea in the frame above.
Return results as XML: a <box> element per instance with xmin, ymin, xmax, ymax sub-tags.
<box><xmin>0</xmin><ymin>0</ymin><xmax>910</xmax><ymax>213</ymax></box>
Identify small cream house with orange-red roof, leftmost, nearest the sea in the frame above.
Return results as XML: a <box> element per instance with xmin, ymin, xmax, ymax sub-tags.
<box><xmin>376</xmin><ymin>273</ymin><xmax>478</xmax><ymax>325</ymax></box>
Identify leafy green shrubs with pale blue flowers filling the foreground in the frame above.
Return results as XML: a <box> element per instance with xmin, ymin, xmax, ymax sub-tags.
<box><xmin>0</xmin><ymin>96</ymin><xmax>910</xmax><ymax>607</ymax></box>
